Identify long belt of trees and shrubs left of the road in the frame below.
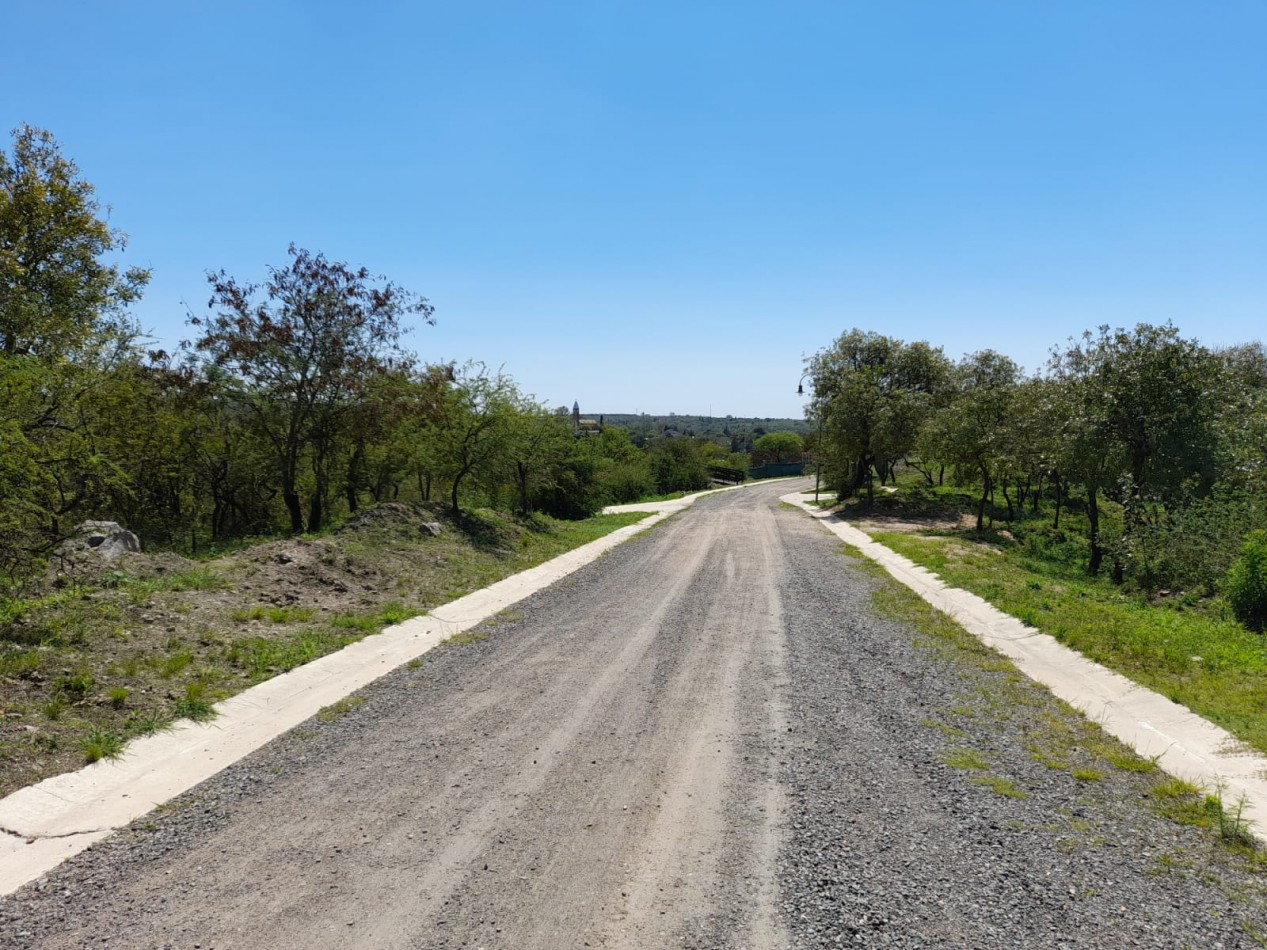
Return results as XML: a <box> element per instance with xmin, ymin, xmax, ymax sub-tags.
<box><xmin>0</xmin><ymin>125</ymin><xmax>798</xmax><ymax>597</ymax></box>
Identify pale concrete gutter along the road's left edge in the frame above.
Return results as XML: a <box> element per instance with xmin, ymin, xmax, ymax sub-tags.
<box><xmin>0</xmin><ymin>483</ymin><xmax>790</xmax><ymax>894</ymax></box>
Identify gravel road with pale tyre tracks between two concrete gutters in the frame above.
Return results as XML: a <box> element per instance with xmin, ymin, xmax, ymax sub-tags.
<box><xmin>0</xmin><ymin>483</ymin><xmax>1267</xmax><ymax>950</ymax></box>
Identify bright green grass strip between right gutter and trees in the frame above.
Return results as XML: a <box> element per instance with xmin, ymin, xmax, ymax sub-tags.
<box><xmin>875</xmin><ymin>533</ymin><xmax>1267</xmax><ymax>752</ymax></box>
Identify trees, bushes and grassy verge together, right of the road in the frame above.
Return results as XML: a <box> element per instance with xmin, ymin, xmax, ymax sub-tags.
<box><xmin>808</xmin><ymin>324</ymin><xmax>1267</xmax><ymax>751</ymax></box>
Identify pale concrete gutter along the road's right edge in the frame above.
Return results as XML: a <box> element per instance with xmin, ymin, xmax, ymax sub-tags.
<box><xmin>782</xmin><ymin>493</ymin><xmax>1267</xmax><ymax>844</ymax></box>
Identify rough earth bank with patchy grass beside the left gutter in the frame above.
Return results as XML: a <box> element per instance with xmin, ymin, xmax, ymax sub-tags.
<box><xmin>0</xmin><ymin>502</ymin><xmax>641</xmax><ymax>795</ymax></box>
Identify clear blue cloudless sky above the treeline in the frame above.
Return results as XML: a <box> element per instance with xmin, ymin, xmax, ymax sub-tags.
<box><xmin>0</xmin><ymin>0</ymin><xmax>1267</xmax><ymax>415</ymax></box>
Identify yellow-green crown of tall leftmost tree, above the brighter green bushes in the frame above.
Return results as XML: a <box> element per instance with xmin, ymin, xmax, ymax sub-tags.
<box><xmin>0</xmin><ymin>125</ymin><xmax>150</xmax><ymax>361</ymax></box>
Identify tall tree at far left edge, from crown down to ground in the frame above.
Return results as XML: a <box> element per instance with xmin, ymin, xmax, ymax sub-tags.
<box><xmin>0</xmin><ymin>125</ymin><xmax>150</xmax><ymax>579</ymax></box>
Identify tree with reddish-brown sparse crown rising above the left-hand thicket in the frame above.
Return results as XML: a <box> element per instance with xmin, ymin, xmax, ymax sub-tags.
<box><xmin>190</xmin><ymin>244</ymin><xmax>435</xmax><ymax>532</ymax></box>
